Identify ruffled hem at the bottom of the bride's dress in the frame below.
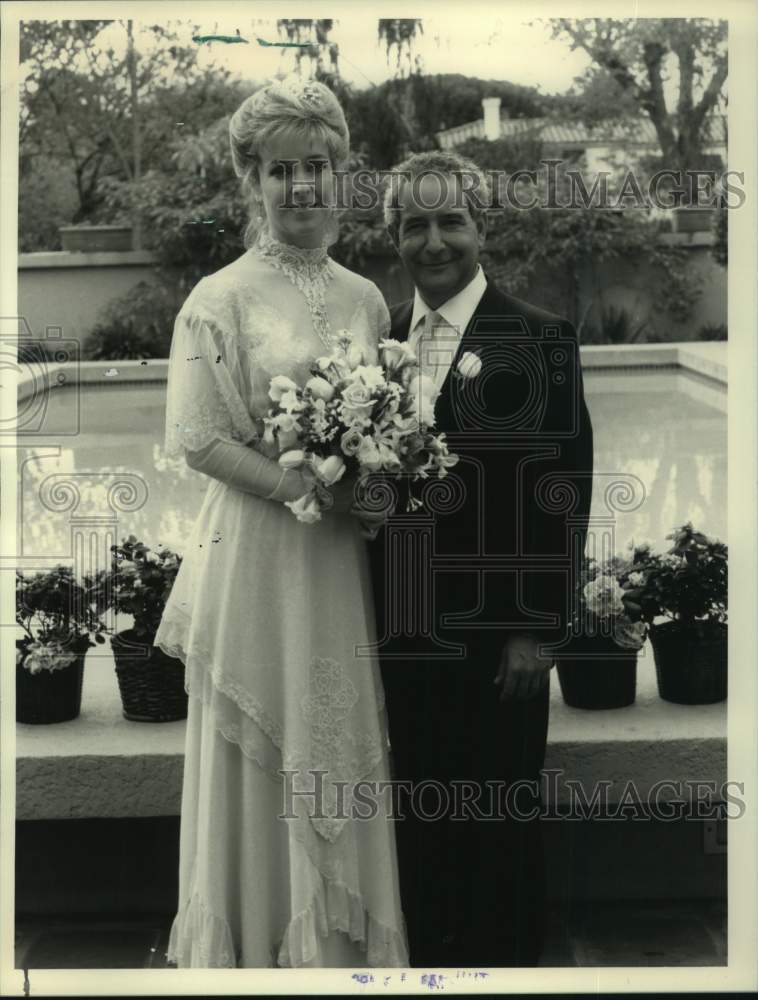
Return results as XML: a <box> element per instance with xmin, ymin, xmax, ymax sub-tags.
<box><xmin>167</xmin><ymin>880</ymin><xmax>408</xmax><ymax>969</ymax></box>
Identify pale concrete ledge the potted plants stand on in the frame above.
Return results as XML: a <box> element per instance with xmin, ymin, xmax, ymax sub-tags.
<box><xmin>16</xmin><ymin>646</ymin><xmax>726</xmax><ymax>820</ymax></box>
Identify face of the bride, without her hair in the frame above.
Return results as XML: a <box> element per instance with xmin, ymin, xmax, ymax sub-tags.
<box><xmin>259</xmin><ymin>136</ymin><xmax>334</xmax><ymax>247</ymax></box>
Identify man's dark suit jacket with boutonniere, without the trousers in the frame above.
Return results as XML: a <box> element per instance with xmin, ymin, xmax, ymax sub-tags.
<box><xmin>371</xmin><ymin>280</ymin><xmax>593</xmax><ymax>646</ymax></box>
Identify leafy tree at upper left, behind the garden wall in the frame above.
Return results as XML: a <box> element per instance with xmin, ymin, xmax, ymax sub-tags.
<box><xmin>20</xmin><ymin>20</ymin><xmax>224</xmax><ymax>230</ymax></box>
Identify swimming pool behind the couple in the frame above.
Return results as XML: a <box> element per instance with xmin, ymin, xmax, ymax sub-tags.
<box><xmin>18</xmin><ymin>362</ymin><xmax>727</xmax><ymax>569</ymax></box>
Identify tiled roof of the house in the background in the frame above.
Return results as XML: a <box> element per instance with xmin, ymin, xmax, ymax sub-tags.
<box><xmin>437</xmin><ymin>115</ymin><xmax>726</xmax><ymax>149</ymax></box>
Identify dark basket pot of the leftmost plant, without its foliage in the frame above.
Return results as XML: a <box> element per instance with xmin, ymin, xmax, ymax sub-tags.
<box><xmin>16</xmin><ymin>636</ymin><xmax>90</xmax><ymax>726</ymax></box>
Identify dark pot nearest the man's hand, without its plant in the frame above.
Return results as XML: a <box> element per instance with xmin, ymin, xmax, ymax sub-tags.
<box><xmin>556</xmin><ymin>635</ymin><xmax>637</xmax><ymax>709</ymax></box>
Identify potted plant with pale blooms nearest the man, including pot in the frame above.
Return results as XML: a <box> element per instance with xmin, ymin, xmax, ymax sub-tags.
<box><xmin>556</xmin><ymin>552</ymin><xmax>646</xmax><ymax>709</ymax></box>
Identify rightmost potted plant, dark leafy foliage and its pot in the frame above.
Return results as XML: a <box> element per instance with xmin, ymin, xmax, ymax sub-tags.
<box><xmin>629</xmin><ymin>523</ymin><xmax>728</xmax><ymax>705</ymax></box>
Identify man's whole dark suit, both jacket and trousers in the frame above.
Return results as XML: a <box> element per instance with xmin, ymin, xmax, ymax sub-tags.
<box><xmin>370</xmin><ymin>281</ymin><xmax>592</xmax><ymax>966</ymax></box>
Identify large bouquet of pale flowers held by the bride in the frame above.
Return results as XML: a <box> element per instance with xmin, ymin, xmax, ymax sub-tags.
<box><xmin>263</xmin><ymin>330</ymin><xmax>458</xmax><ymax>523</ymax></box>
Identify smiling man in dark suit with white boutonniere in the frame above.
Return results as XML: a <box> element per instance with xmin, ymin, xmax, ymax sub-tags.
<box><xmin>371</xmin><ymin>151</ymin><xmax>592</xmax><ymax>966</ymax></box>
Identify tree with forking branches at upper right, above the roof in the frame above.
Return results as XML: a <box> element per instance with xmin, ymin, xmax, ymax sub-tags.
<box><xmin>549</xmin><ymin>17</ymin><xmax>728</xmax><ymax>170</ymax></box>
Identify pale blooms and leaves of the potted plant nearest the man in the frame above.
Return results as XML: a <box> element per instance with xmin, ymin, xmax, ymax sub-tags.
<box><xmin>580</xmin><ymin>546</ymin><xmax>648</xmax><ymax>649</ymax></box>
